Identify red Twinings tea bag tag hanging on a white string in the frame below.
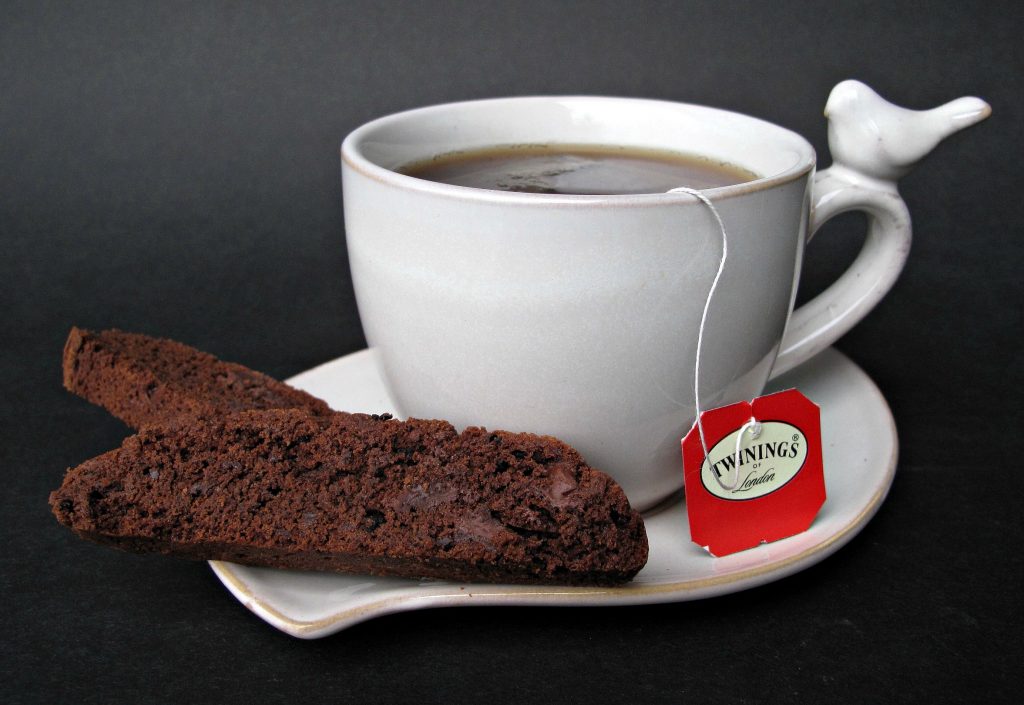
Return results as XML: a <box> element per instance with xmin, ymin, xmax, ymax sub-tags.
<box><xmin>682</xmin><ymin>389</ymin><xmax>825</xmax><ymax>556</ymax></box>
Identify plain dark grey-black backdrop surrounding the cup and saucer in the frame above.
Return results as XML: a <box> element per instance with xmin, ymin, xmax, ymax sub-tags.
<box><xmin>0</xmin><ymin>1</ymin><xmax>1024</xmax><ymax>703</ymax></box>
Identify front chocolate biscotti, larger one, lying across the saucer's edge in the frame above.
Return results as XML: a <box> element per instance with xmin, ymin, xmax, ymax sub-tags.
<box><xmin>50</xmin><ymin>409</ymin><xmax>647</xmax><ymax>585</ymax></box>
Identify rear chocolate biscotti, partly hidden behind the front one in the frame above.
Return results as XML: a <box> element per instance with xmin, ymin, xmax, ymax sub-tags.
<box><xmin>63</xmin><ymin>328</ymin><xmax>331</xmax><ymax>429</ymax></box>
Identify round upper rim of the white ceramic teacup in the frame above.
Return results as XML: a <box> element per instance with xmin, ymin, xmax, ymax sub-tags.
<box><xmin>341</xmin><ymin>94</ymin><xmax>817</xmax><ymax>206</ymax></box>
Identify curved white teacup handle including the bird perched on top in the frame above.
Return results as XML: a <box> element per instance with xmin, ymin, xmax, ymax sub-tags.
<box><xmin>771</xmin><ymin>81</ymin><xmax>991</xmax><ymax>377</ymax></box>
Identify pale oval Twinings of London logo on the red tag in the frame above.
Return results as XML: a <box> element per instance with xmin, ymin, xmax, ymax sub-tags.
<box><xmin>700</xmin><ymin>421</ymin><xmax>807</xmax><ymax>500</ymax></box>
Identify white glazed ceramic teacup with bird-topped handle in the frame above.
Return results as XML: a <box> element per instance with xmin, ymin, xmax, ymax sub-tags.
<box><xmin>342</xmin><ymin>81</ymin><xmax>988</xmax><ymax>509</ymax></box>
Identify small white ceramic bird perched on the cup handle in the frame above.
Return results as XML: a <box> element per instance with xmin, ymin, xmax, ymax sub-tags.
<box><xmin>825</xmin><ymin>81</ymin><xmax>992</xmax><ymax>181</ymax></box>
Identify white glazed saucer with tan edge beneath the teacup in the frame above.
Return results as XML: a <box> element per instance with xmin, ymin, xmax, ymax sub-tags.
<box><xmin>210</xmin><ymin>349</ymin><xmax>897</xmax><ymax>638</ymax></box>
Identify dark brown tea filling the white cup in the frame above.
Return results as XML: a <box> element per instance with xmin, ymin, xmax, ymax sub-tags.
<box><xmin>399</xmin><ymin>144</ymin><xmax>758</xmax><ymax>196</ymax></box>
